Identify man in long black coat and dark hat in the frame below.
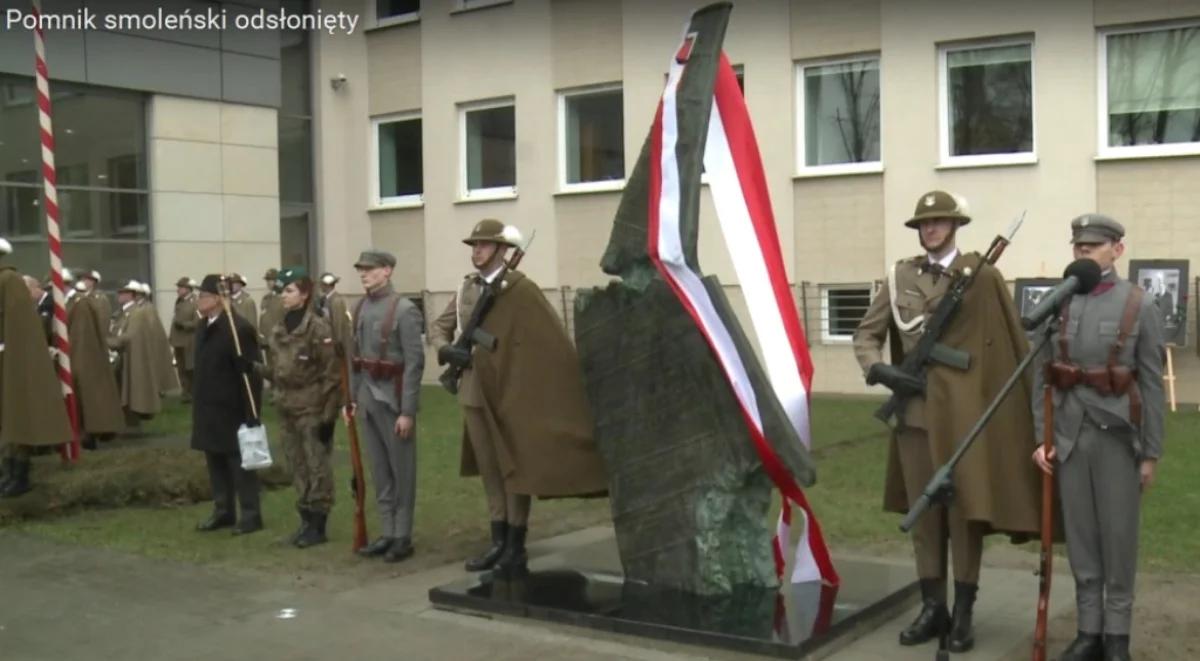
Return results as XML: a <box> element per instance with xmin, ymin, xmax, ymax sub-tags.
<box><xmin>192</xmin><ymin>275</ymin><xmax>263</xmax><ymax>535</ymax></box>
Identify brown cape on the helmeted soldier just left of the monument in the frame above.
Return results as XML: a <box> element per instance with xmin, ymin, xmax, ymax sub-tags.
<box><xmin>451</xmin><ymin>271</ymin><xmax>608</xmax><ymax>497</ymax></box>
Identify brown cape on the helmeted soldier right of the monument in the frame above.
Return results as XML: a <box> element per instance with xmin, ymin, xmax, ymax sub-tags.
<box><xmin>883</xmin><ymin>253</ymin><xmax>1042</xmax><ymax>537</ymax></box>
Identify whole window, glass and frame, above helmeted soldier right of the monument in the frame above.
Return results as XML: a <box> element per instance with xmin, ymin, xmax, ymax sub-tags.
<box><xmin>938</xmin><ymin>42</ymin><xmax>1036</xmax><ymax>166</ymax></box>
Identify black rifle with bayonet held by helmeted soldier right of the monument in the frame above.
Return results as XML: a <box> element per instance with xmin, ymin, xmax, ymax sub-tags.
<box><xmin>875</xmin><ymin>211</ymin><xmax>1025</xmax><ymax>426</ymax></box>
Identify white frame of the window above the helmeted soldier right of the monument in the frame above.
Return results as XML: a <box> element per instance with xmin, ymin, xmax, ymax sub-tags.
<box><xmin>937</xmin><ymin>35</ymin><xmax>1038</xmax><ymax>168</ymax></box>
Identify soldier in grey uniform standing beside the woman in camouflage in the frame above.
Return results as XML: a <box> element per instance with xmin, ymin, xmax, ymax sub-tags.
<box><xmin>346</xmin><ymin>250</ymin><xmax>425</xmax><ymax>563</ymax></box>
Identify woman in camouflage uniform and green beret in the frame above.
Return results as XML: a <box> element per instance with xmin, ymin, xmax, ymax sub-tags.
<box><xmin>268</xmin><ymin>268</ymin><xmax>341</xmax><ymax>548</ymax></box>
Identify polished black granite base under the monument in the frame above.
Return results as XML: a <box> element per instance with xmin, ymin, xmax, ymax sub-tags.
<box><xmin>430</xmin><ymin>544</ymin><xmax>917</xmax><ymax>659</ymax></box>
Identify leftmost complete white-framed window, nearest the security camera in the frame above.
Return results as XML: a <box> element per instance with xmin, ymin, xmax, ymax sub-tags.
<box><xmin>372</xmin><ymin>116</ymin><xmax>424</xmax><ymax>206</ymax></box>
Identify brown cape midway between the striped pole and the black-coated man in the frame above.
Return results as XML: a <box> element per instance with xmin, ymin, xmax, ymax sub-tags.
<box><xmin>121</xmin><ymin>304</ymin><xmax>176</xmax><ymax>415</ymax></box>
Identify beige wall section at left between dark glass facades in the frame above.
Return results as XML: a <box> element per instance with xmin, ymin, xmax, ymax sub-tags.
<box><xmin>148</xmin><ymin>96</ymin><xmax>280</xmax><ymax>322</ymax></box>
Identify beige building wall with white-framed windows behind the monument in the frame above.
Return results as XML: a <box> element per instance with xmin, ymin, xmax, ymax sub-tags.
<box><xmin>331</xmin><ymin>0</ymin><xmax>1200</xmax><ymax>399</ymax></box>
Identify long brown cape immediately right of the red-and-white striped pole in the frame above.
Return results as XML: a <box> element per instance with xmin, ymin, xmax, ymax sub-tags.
<box><xmin>67</xmin><ymin>298</ymin><xmax>125</xmax><ymax>434</ymax></box>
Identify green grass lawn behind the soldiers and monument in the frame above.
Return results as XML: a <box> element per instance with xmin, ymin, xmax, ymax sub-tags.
<box><xmin>10</xmin><ymin>387</ymin><xmax>1200</xmax><ymax>578</ymax></box>
